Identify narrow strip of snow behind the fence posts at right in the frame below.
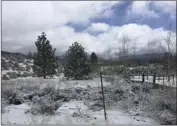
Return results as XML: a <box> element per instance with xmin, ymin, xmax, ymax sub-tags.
<box><xmin>131</xmin><ymin>76</ymin><xmax>176</xmax><ymax>87</ymax></box>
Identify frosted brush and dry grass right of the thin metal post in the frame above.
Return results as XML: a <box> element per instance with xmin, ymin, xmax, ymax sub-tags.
<box><xmin>105</xmin><ymin>75</ymin><xmax>176</xmax><ymax>124</ymax></box>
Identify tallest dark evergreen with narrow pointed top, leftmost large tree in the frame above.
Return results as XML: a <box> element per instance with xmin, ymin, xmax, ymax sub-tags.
<box><xmin>33</xmin><ymin>32</ymin><xmax>56</xmax><ymax>78</ymax></box>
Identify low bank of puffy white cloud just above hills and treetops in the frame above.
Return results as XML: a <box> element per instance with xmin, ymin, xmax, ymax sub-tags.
<box><xmin>3</xmin><ymin>21</ymin><xmax>176</xmax><ymax>54</ymax></box>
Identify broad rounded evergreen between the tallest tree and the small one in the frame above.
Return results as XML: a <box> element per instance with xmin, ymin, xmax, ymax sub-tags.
<box><xmin>64</xmin><ymin>42</ymin><xmax>90</xmax><ymax>79</ymax></box>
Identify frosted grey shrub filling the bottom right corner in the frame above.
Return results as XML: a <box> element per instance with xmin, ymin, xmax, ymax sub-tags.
<box><xmin>147</xmin><ymin>87</ymin><xmax>176</xmax><ymax>125</ymax></box>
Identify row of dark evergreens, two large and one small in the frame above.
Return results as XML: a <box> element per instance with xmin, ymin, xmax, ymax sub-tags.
<box><xmin>28</xmin><ymin>32</ymin><xmax>98</xmax><ymax>79</ymax></box>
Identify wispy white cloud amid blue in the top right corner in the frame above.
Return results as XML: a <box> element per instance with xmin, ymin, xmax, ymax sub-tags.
<box><xmin>127</xmin><ymin>1</ymin><xmax>176</xmax><ymax>18</ymax></box>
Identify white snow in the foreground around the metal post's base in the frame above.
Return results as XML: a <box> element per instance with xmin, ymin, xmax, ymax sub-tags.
<box><xmin>2</xmin><ymin>101</ymin><xmax>158</xmax><ymax>124</ymax></box>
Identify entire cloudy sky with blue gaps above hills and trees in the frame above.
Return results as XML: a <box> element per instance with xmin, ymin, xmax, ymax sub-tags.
<box><xmin>2</xmin><ymin>1</ymin><xmax>176</xmax><ymax>54</ymax></box>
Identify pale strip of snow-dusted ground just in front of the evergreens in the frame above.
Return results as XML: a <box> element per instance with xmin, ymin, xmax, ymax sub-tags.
<box><xmin>3</xmin><ymin>77</ymin><xmax>110</xmax><ymax>89</ymax></box>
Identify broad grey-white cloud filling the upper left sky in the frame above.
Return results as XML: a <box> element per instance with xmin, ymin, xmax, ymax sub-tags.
<box><xmin>2</xmin><ymin>1</ymin><xmax>118</xmax><ymax>34</ymax></box>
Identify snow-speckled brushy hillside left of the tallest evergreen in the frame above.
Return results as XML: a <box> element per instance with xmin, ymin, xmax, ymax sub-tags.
<box><xmin>1</xmin><ymin>51</ymin><xmax>33</xmax><ymax>80</ymax></box>
